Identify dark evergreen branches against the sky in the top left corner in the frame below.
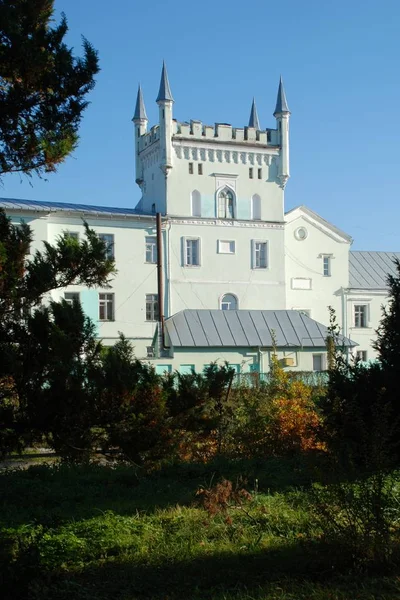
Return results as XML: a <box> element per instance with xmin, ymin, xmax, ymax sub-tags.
<box><xmin>0</xmin><ymin>0</ymin><xmax>99</xmax><ymax>177</ymax></box>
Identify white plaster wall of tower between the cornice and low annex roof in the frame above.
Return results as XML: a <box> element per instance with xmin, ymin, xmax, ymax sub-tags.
<box><xmin>169</xmin><ymin>220</ymin><xmax>285</xmax><ymax>315</ymax></box>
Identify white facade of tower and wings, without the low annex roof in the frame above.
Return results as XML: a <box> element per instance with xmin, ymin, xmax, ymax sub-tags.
<box><xmin>2</xmin><ymin>67</ymin><xmax>396</xmax><ymax>370</ymax></box>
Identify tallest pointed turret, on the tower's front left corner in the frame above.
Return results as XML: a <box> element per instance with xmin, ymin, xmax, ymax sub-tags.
<box><xmin>156</xmin><ymin>62</ymin><xmax>174</xmax><ymax>176</ymax></box>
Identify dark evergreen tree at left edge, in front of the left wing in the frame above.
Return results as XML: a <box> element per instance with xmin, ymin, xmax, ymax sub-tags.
<box><xmin>0</xmin><ymin>210</ymin><xmax>115</xmax><ymax>452</ymax></box>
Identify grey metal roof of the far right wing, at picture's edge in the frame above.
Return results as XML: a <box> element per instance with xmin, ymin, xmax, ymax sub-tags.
<box><xmin>349</xmin><ymin>251</ymin><xmax>400</xmax><ymax>289</ymax></box>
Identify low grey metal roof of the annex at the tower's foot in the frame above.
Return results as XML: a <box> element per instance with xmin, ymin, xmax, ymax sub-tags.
<box><xmin>165</xmin><ymin>309</ymin><xmax>357</xmax><ymax>348</ymax></box>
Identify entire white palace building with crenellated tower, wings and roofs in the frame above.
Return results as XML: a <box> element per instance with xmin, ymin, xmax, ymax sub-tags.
<box><xmin>0</xmin><ymin>65</ymin><xmax>400</xmax><ymax>372</ymax></box>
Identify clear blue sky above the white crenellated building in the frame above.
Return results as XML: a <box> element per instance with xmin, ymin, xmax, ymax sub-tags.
<box><xmin>0</xmin><ymin>0</ymin><xmax>400</xmax><ymax>251</ymax></box>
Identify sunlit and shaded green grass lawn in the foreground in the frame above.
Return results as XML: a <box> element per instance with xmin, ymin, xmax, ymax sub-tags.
<box><xmin>0</xmin><ymin>460</ymin><xmax>400</xmax><ymax>600</ymax></box>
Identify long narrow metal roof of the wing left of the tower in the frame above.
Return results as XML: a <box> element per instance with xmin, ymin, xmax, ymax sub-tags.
<box><xmin>0</xmin><ymin>198</ymin><xmax>150</xmax><ymax>217</ymax></box>
